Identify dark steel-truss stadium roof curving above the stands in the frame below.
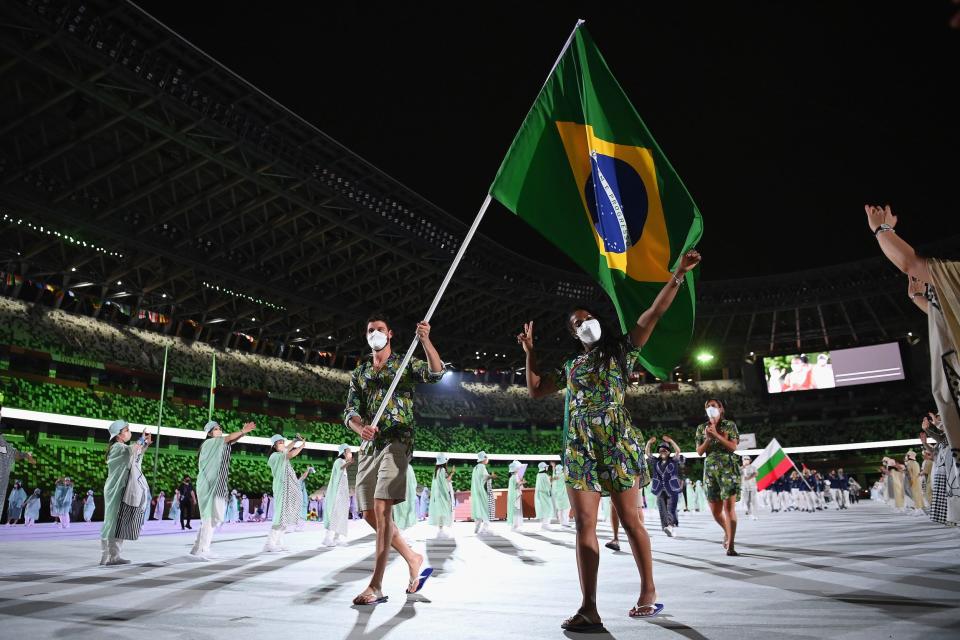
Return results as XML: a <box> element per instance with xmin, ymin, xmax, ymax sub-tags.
<box><xmin>0</xmin><ymin>0</ymin><xmax>956</xmax><ymax>367</ymax></box>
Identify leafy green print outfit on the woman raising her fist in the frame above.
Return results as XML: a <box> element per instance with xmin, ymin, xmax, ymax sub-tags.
<box><xmin>554</xmin><ymin>345</ymin><xmax>650</xmax><ymax>496</ymax></box>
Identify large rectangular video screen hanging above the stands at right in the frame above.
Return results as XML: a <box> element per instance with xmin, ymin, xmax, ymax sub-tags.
<box><xmin>763</xmin><ymin>342</ymin><xmax>904</xmax><ymax>393</ymax></box>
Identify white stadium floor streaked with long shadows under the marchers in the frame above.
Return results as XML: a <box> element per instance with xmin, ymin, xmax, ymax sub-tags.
<box><xmin>0</xmin><ymin>502</ymin><xmax>960</xmax><ymax>640</ymax></box>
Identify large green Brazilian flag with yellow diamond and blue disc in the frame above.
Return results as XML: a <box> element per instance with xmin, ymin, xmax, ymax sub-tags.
<box><xmin>490</xmin><ymin>26</ymin><xmax>703</xmax><ymax>380</ymax></box>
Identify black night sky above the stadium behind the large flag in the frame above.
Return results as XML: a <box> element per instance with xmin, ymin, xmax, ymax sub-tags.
<box><xmin>131</xmin><ymin>0</ymin><xmax>960</xmax><ymax>280</ymax></box>
